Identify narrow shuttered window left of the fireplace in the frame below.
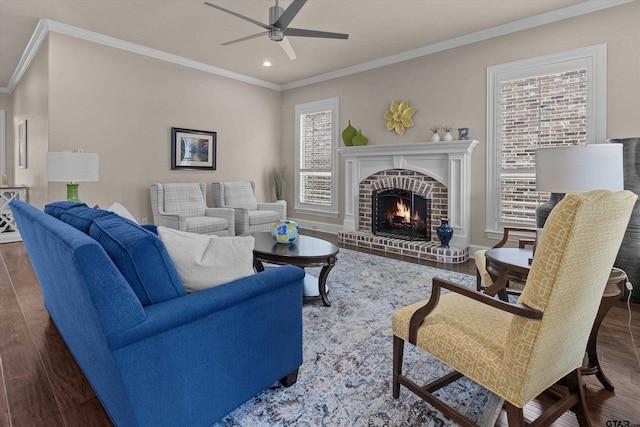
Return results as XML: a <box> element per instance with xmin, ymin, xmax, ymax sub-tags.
<box><xmin>295</xmin><ymin>98</ymin><xmax>339</xmax><ymax>216</ymax></box>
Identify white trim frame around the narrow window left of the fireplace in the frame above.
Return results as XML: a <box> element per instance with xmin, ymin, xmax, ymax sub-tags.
<box><xmin>294</xmin><ymin>97</ymin><xmax>340</xmax><ymax>218</ymax></box>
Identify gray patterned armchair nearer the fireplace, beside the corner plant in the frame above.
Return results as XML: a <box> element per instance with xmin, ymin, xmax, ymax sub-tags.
<box><xmin>211</xmin><ymin>181</ymin><xmax>287</xmax><ymax>234</ymax></box>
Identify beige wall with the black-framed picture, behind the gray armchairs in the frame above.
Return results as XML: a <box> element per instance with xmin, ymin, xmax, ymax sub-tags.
<box><xmin>14</xmin><ymin>33</ymin><xmax>281</xmax><ymax>222</ymax></box>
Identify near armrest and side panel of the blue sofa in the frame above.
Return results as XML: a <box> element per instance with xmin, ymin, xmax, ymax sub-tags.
<box><xmin>110</xmin><ymin>266</ymin><xmax>304</xmax><ymax>426</ymax></box>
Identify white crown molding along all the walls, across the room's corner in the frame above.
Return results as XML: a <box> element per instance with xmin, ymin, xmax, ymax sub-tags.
<box><xmin>0</xmin><ymin>0</ymin><xmax>636</xmax><ymax>93</ymax></box>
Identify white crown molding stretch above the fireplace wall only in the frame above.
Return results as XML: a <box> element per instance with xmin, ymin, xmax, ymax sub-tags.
<box><xmin>282</xmin><ymin>0</ymin><xmax>636</xmax><ymax>90</ymax></box>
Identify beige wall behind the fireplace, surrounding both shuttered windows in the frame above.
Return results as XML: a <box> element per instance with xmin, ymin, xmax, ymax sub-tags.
<box><xmin>282</xmin><ymin>2</ymin><xmax>640</xmax><ymax>246</ymax></box>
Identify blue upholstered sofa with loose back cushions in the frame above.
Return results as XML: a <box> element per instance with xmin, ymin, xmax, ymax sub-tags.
<box><xmin>11</xmin><ymin>201</ymin><xmax>304</xmax><ymax>427</ymax></box>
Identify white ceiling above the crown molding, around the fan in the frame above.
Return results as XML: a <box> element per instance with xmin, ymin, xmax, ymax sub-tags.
<box><xmin>0</xmin><ymin>0</ymin><xmax>632</xmax><ymax>91</ymax></box>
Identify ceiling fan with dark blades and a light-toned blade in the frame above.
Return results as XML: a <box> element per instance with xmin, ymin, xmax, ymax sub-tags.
<box><xmin>204</xmin><ymin>0</ymin><xmax>349</xmax><ymax>60</ymax></box>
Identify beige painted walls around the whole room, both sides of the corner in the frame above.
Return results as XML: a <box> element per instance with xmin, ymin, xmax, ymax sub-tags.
<box><xmin>6</xmin><ymin>2</ymin><xmax>640</xmax><ymax>246</ymax></box>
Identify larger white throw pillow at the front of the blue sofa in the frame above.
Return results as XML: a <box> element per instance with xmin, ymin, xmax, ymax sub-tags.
<box><xmin>158</xmin><ymin>226</ymin><xmax>255</xmax><ymax>292</ymax></box>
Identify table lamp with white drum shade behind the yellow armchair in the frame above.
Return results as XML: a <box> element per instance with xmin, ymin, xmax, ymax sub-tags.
<box><xmin>536</xmin><ymin>144</ymin><xmax>624</xmax><ymax>228</ymax></box>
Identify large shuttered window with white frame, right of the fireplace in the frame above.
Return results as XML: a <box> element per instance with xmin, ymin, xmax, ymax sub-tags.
<box><xmin>487</xmin><ymin>45</ymin><xmax>606</xmax><ymax>238</ymax></box>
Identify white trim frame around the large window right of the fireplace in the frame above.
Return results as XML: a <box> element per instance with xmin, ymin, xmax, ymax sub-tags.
<box><xmin>485</xmin><ymin>43</ymin><xmax>607</xmax><ymax>239</ymax></box>
